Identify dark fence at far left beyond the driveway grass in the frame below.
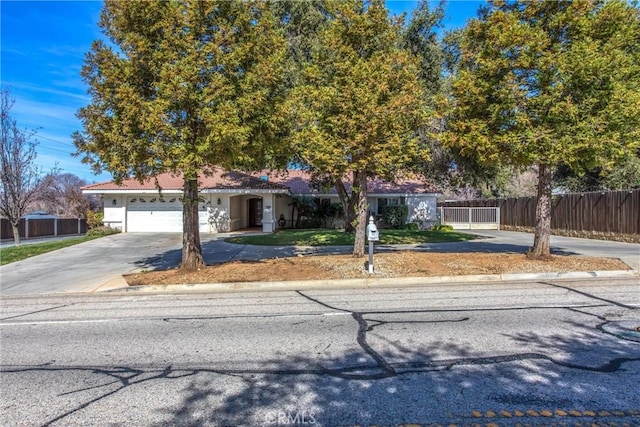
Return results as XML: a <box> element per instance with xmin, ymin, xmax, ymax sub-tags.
<box><xmin>0</xmin><ymin>218</ymin><xmax>87</xmax><ymax>240</ymax></box>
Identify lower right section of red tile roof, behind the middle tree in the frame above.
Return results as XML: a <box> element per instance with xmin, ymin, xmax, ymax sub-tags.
<box><xmin>253</xmin><ymin>169</ymin><xmax>440</xmax><ymax>194</ymax></box>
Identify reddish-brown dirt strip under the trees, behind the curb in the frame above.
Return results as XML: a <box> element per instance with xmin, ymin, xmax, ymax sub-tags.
<box><xmin>125</xmin><ymin>251</ymin><xmax>629</xmax><ymax>286</ymax></box>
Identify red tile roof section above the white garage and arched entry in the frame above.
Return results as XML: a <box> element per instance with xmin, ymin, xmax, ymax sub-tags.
<box><xmin>82</xmin><ymin>169</ymin><xmax>288</xmax><ymax>192</ymax></box>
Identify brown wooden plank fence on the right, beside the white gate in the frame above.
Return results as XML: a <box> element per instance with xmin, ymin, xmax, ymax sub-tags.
<box><xmin>438</xmin><ymin>189</ymin><xmax>640</xmax><ymax>234</ymax></box>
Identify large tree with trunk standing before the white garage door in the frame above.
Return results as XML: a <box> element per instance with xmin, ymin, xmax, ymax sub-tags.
<box><xmin>74</xmin><ymin>0</ymin><xmax>286</xmax><ymax>269</ymax></box>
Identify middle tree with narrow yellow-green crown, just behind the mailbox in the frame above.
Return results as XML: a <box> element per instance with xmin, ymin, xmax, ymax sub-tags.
<box><xmin>290</xmin><ymin>0</ymin><xmax>426</xmax><ymax>256</ymax></box>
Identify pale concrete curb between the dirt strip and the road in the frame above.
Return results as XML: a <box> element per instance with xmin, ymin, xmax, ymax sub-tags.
<box><xmin>95</xmin><ymin>270</ymin><xmax>640</xmax><ymax>293</ymax></box>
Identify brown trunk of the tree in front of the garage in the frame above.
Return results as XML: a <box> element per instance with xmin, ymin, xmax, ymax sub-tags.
<box><xmin>180</xmin><ymin>177</ymin><xmax>204</xmax><ymax>270</ymax></box>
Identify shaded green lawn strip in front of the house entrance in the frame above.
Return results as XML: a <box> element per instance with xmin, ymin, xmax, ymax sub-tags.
<box><xmin>226</xmin><ymin>229</ymin><xmax>476</xmax><ymax>246</ymax></box>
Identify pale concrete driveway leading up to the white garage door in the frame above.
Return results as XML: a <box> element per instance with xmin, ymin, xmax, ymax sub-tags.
<box><xmin>0</xmin><ymin>233</ymin><xmax>182</xmax><ymax>295</ymax></box>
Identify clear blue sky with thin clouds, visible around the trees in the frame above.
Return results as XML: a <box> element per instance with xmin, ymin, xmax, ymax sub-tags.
<box><xmin>0</xmin><ymin>0</ymin><xmax>482</xmax><ymax>182</ymax></box>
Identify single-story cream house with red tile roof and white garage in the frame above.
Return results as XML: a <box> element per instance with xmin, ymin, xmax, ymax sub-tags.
<box><xmin>82</xmin><ymin>168</ymin><xmax>439</xmax><ymax>233</ymax></box>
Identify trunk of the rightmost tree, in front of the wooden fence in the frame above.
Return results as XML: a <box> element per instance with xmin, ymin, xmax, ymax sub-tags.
<box><xmin>528</xmin><ymin>164</ymin><xmax>552</xmax><ymax>259</ymax></box>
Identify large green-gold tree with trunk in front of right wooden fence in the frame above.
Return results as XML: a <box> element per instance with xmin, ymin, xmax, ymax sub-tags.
<box><xmin>446</xmin><ymin>0</ymin><xmax>640</xmax><ymax>257</ymax></box>
